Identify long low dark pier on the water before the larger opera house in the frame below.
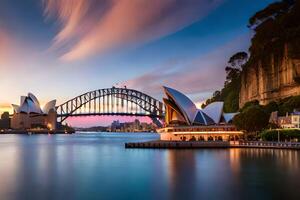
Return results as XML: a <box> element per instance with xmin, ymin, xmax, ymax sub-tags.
<box><xmin>125</xmin><ymin>140</ymin><xmax>300</xmax><ymax>150</ymax></box>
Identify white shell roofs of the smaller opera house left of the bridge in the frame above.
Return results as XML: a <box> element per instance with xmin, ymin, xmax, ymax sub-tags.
<box><xmin>12</xmin><ymin>93</ymin><xmax>56</xmax><ymax>114</ymax></box>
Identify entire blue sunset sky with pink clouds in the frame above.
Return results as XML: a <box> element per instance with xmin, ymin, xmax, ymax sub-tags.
<box><xmin>0</xmin><ymin>0</ymin><xmax>274</xmax><ymax>125</ymax></box>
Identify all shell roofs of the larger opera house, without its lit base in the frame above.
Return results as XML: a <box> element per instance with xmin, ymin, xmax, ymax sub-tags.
<box><xmin>164</xmin><ymin>87</ymin><xmax>237</xmax><ymax>125</ymax></box>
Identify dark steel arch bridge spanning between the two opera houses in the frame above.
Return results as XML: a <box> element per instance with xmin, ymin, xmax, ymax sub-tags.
<box><xmin>56</xmin><ymin>87</ymin><xmax>165</xmax><ymax>126</ymax></box>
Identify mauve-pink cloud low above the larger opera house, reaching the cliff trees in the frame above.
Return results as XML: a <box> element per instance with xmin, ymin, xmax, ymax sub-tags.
<box><xmin>122</xmin><ymin>35</ymin><xmax>250</xmax><ymax>102</ymax></box>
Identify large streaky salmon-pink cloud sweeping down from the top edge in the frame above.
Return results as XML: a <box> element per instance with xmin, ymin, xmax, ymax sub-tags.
<box><xmin>44</xmin><ymin>0</ymin><xmax>223</xmax><ymax>61</ymax></box>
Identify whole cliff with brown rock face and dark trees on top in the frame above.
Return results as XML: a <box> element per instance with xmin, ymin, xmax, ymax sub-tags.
<box><xmin>239</xmin><ymin>0</ymin><xmax>300</xmax><ymax>107</ymax></box>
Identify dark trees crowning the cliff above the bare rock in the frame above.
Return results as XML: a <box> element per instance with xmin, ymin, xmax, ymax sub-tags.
<box><xmin>246</xmin><ymin>0</ymin><xmax>300</xmax><ymax>72</ymax></box>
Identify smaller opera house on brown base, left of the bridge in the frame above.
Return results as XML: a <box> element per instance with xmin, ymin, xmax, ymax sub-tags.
<box><xmin>11</xmin><ymin>93</ymin><xmax>57</xmax><ymax>130</ymax></box>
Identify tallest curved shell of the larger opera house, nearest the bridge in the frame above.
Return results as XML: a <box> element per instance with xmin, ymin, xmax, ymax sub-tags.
<box><xmin>164</xmin><ymin>87</ymin><xmax>198</xmax><ymax>124</ymax></box>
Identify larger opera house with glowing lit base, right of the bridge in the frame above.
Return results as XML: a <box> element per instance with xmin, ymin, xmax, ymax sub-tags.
<box><xmin>158</xmin><ymin>87</ymin><xmax>243</xmax><ymax>141</ymax></box>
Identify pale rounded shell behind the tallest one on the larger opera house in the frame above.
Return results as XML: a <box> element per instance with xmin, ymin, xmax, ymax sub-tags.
<box><xmin>202</xmin><ymin>101</ymin><xmax>224</xmax><ymax>124</ymax></box>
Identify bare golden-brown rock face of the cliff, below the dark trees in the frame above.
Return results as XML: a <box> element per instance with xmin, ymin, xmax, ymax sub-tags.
<box><xmin>240</xmin><ymin>45</ymin><xmax>300</xmax><ymax>107</ymax></box>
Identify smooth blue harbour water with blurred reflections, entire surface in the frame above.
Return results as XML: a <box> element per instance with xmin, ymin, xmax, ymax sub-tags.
<box><xmin>0</xmin><ymin>133</ymin><xmax>300</xmax><ymax>200</ymax></box>
